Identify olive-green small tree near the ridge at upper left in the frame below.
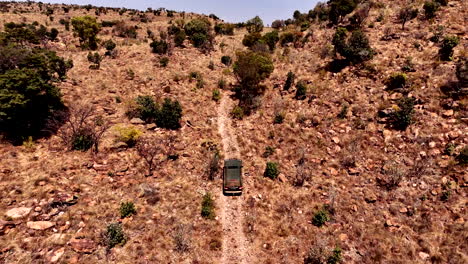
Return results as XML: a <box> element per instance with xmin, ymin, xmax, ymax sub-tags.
<box><xmin>71</xmin><ymin>16</ymin><xmax>101</xmax><ymax>50</ymax></box>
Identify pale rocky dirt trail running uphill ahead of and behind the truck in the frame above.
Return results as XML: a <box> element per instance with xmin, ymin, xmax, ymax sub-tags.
<box><xmin>218</xmin><ymin>94</ymin><xmax>249</xmax><ymax>264</ymax></box>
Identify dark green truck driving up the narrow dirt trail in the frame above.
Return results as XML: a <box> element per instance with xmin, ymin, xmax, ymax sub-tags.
<box><xmin>223</xmin><ymin>159</ymin><xmax>243</xmax><ymax>195</ymax></box>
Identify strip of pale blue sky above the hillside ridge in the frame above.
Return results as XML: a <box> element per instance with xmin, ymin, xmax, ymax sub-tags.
<box><xmin>22</xmin><ymin>0</ymin><xmax>326</xmax><ymax>24</ymax></box>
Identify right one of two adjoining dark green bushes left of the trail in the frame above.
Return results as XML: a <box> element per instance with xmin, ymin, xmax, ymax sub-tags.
<box><xmin>156</xmin><ymin>98</ymin><xmax>182</xmax><ymax>130</ymax></box>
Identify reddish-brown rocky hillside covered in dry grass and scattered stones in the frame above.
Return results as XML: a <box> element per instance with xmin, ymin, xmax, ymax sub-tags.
<box><xmin>0</xmin><ymin>1</ymin><xmax>468</xmax><ymax>263</ymax></box>
